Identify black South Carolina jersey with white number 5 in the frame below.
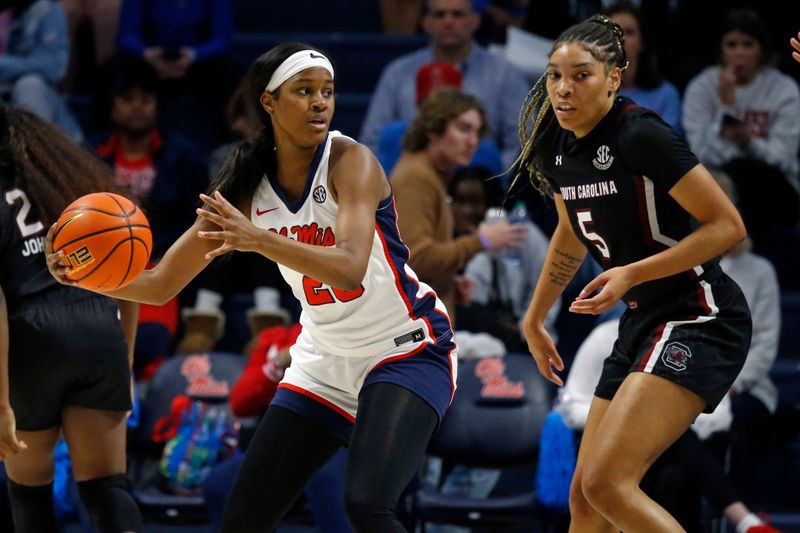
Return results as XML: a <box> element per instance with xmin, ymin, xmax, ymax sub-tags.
<box><xmin>542</xmin><ymin>96</ymin><xmax>719</xmax><ymax>308</ymax></box>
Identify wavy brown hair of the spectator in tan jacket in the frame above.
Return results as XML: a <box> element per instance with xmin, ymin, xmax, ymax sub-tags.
<box><xmin>403</xmin><ymin>87</ymin><xmax>486</xmax><ymax>152</ymax></box>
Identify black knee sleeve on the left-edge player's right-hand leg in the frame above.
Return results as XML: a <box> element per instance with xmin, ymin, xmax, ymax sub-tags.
<box><xmin>78</xmin><ymin>474</ymin><xmax>142</xmax><ymax>533</ymax></box>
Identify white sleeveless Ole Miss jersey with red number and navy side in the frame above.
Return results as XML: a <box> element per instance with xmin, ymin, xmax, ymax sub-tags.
<box><xmin>250</xmin><ymin>131</ymin><xmax>452</xmax><ymax>357</ymax></box>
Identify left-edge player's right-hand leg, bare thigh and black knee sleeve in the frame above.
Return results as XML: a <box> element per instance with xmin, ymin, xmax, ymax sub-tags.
<box><xmin>63</xmin><ymin>405</ymin><xmax>142</xmax><ymax>532</ymax></box>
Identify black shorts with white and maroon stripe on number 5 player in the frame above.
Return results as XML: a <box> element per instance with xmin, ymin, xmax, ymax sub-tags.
<box><xmin>595</xmin><ymin>273</ymin><xmax>752</xmax><ymax>413</ymax></box>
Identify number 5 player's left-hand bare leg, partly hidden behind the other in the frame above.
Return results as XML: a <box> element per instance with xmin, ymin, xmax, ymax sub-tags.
<box><xmin>569</xmin><ymin>396</ymin><xmax>618</xmax><ymax>533</ymax></box>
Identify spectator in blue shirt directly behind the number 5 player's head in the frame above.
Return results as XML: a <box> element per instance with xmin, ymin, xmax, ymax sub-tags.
<box><xmin>606</xmin><ymin>0</ymin><xmax>683</xmax><ymax>133</ymax></box>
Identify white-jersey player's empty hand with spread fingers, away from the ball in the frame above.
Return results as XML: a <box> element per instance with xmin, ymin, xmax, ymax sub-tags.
<box><xmin>197</xmin><ymin>191</ymin><xmax>261</xmax><ymax>259</ymax></box>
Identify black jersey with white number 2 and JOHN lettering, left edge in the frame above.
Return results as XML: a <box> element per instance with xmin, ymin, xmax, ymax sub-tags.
<box><xmin>0</xmin><ymin>166</ymin><xmax>59</xmax><ymax>310</ymax></box>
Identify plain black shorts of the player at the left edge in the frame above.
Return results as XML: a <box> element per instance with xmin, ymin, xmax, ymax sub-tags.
<box><xmin>9</xmin><ymin>287</ymin><xmax>131</xmax><ymax>431</ymax></box>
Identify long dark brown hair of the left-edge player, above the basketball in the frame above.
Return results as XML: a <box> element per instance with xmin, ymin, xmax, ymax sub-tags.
<box><xmin>0</xmin><ymin>105</ymin><xmax>120</xmax><ymax>225</ymax></box>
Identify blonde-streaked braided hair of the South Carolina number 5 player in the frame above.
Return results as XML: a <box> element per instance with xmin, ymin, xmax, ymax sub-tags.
<box><xmin>509</xmin><ymin>15</ymin><xmax>628</xmax><ymax>195</ymax></box>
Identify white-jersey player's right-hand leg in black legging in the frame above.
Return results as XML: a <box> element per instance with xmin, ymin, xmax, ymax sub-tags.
<box><xmin>345</xmin><ymin>382</ymin><xmax>439</xmax><ymax>533</ymax></box>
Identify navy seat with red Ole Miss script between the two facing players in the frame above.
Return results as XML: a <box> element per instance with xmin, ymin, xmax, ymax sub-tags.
<box><xmin>415</xmin><ymin>354</ymin><xmax>550</xmax><ymax>531</ymax></box>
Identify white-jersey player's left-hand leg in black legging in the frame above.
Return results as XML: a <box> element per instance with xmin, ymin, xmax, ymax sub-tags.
<box><xmin>222</xmin><ymin>404</ymin><xmax>343</xmax><ymax>533</ymax></box>
